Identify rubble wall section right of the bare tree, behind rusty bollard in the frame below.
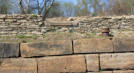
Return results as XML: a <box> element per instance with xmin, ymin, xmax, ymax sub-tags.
<box><xmin>46</xmin><ymin>16</ymin><xmax>134</xmax><ymax>33</ymax></box>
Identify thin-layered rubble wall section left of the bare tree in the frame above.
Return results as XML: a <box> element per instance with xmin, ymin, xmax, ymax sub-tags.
<box><xmin>0</xmin><ymin>14</ymin><xmax>44</xmax><ymax>36</ymax></box>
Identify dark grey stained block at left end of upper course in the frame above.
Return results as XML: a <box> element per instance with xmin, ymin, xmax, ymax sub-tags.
<box><xmin>0</xmin><ymin>43</ymin><xmax>19</xmax><ymax>57</ymax></box>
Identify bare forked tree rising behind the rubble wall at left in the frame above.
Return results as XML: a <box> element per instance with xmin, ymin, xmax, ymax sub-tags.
<box><xmin>18</xmin><ymin>0</ymin><xmax>54</xmax><ymax>20</ymax></box>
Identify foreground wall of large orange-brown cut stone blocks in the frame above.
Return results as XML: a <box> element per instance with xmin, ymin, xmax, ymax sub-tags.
<box><xmin>0</xmin><ymin>38</ymin><xmax>134</xmax><ymax>73</ymax></box>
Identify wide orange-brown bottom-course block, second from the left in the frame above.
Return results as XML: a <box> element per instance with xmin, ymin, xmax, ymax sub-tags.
<box><xmin>38</xmin><ymin>55</ymin><xmax>86</xmax><ymax>73</ymax></box>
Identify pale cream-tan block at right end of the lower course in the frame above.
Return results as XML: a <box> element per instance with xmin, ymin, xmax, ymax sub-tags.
<box><xmin>100</xmin><ymin>53</ymin><xmax>134</xmax><ymax>70</ymax></box>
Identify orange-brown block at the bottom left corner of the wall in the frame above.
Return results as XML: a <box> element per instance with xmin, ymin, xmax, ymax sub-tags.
<box><xmin>0</xmin><ymin>58</ymin><xmax>37</xmax><ymax>73</ymax></box>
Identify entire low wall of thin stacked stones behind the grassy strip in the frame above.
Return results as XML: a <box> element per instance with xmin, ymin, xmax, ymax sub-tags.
<box><xmin>0</xmin><ymin>14</ymin><xmax>134</xmax><ymax>36</ymax></box>
